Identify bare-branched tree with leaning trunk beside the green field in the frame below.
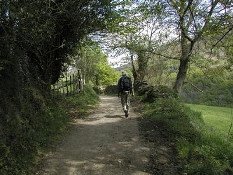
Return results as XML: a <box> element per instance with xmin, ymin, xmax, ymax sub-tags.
<box><xmin>140</xmin><ymin>0</ymin><xmax>232</xmax><ymax>92</ymax></box>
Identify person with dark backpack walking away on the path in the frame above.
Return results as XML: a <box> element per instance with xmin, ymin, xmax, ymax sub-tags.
<box><xmin>118</xmin><ymin>71</ymin><xmax>134</xmax><ymax>118</ymax></box>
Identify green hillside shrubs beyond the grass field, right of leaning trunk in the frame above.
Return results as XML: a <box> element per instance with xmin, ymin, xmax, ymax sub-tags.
<box><xmin>182</xmin><ymin>66</ymin><xmax>233</xmax><ymax>107</ymax></box>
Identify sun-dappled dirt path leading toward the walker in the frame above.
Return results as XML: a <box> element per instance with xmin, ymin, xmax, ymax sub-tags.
<box><xmin>38</xmin><ymin>96</ymin><xmax>150</xmax><ymax>175</ymax></box>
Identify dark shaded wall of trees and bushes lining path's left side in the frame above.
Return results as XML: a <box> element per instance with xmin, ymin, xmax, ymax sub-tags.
<box><xmin>0</xmin><ymin>0</ymin><xmax>114</xmax><ymax>174</ymax></box>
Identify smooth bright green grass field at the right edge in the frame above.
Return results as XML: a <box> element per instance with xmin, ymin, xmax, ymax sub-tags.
<box><xmin>187</xmin><ymin>104</ymin><xmax>233</xmax><ymax>135</ymax></box>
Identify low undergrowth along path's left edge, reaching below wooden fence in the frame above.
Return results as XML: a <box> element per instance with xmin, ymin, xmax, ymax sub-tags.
<box><xmin>0</xmin><ymin>86</ymin><xmax>98</xmax><ymax>175</ymax></box>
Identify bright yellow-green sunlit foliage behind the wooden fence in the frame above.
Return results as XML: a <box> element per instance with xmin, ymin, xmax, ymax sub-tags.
<box><xmin>71</xmin><ymin>40</ymin><xmax>119</xmax><ymax>87</ymax></box>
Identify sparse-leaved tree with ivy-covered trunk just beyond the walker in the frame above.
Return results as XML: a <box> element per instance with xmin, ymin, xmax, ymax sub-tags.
<box><xmin>100</xmin><ymin>8</ymin><xmax>162</xmax><ymax>81</ymax></box>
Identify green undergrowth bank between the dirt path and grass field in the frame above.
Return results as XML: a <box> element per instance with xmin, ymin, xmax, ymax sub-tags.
<box><xmin>143</xmin><ymin>98</ymin><xmax>233</xmax><ymax>175</ymax></box>
